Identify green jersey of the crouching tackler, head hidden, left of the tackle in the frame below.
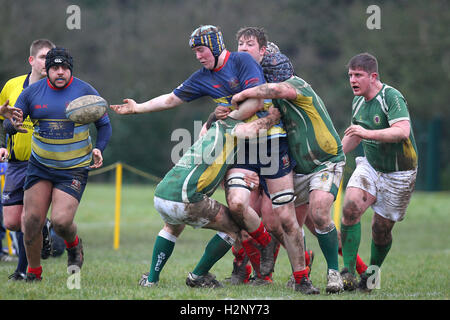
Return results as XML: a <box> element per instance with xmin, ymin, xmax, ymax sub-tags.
<box><xmin>155</xmin><ymin>118</ymin><xmax>241</xmax><ymax>203</ymax></box>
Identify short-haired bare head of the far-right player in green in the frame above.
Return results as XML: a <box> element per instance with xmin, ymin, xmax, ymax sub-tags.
<box><xmin>347</xmin><ymin>52</ymin><xmax>379</xmax><ymax>98</ymax></box>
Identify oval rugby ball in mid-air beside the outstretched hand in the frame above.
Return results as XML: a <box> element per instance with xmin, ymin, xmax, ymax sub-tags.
<box><xmin>66</xmin><ymin>95</ymin><xmax>108</xmax><ymax>124</ymax></box>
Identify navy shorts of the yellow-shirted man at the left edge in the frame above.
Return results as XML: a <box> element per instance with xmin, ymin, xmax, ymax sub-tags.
<box><xmin>2</xmin><ymin>161</ymin><xmax>28</xmax><ymax>206</ymax></box>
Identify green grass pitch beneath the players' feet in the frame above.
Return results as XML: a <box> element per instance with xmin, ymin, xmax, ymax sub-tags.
<box><xmin>0</xmin><ymin>183</ymin><xmax>450</xmax><ymax>300</ymax></box>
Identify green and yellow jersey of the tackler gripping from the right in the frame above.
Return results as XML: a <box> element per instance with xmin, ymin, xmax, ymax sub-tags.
<box><xmin>273</xmin><ymin>76</ymin><xmax>345</xmax><ymax>174</ymax></box>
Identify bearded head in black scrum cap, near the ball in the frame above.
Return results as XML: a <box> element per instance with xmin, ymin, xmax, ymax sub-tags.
<box><xmin>45</xmin><ymin>47</ymin><xmax>73</xmax><ymax>88</ymax></box>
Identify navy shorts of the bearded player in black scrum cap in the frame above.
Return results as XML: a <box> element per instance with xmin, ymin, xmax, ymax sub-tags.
<box><xmin>24</xmin><ymin>158</ymin><xmax>89</xmax><ymax>202</ymax></box>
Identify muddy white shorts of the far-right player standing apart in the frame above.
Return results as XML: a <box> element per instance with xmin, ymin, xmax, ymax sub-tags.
<box><xmin>347</xmin><ymin>157</ymin><xmax>417</xmax><ymax>221</ymax></box>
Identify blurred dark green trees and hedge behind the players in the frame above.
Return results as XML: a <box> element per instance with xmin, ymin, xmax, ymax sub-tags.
<box><xmin>0</xmin><ymin>0</ymin><xmax>450</xmax><ymax>189</ymax></box>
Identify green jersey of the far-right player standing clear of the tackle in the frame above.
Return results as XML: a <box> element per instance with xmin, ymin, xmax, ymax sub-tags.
<box><xmin>352</xmin><ymin>84</ymin><xmax>418</xmax><ymax>173</ymax></box>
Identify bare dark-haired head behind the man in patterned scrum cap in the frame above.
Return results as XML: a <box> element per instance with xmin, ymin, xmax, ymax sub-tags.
<box><xmin>236</xmin><ymin>27</ymin><xmax>267</xmax><ymax>63</ymax></box>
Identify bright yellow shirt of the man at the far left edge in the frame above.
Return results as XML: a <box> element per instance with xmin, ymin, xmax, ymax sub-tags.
<box><xmin>0</xmin><ymin>74</ymin><xmax>33</xmax><ymax>161</ymax></box>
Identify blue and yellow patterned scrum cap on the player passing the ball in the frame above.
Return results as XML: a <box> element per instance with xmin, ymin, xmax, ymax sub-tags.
<box><xmin>189</xmin><ymin>25</ymin><xmax>225</xmax><ymax>69</ymax></box>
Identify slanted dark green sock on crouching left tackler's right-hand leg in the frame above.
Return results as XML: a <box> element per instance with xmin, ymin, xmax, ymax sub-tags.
<box><xmin>192</xmin><ymin>234</ymin><xmax>231</xmax><ymax>276</ymax></box>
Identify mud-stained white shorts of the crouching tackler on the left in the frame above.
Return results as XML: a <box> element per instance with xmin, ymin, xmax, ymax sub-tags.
<box><xmin>153</xmin><ymin>196</ymin><xmax>220</xmax><ymax>228</ymax></box>
